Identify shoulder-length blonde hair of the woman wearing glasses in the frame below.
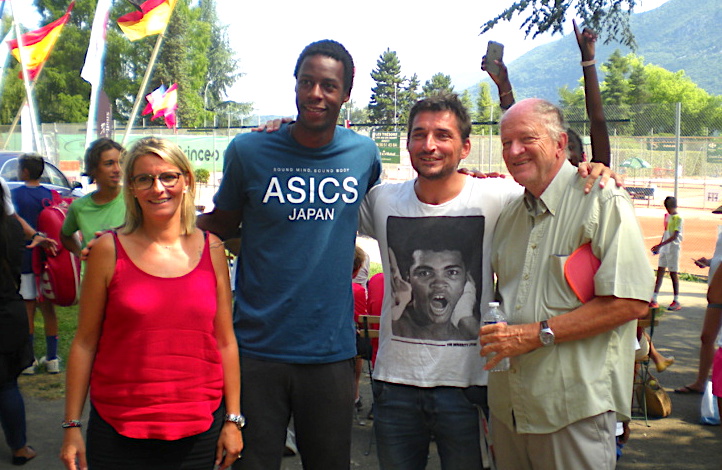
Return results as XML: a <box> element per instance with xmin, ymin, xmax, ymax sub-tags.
<box><xmin>121</xmin><ymin>137</ymin><xmax>196</xmax><ymax>235</ymax></box>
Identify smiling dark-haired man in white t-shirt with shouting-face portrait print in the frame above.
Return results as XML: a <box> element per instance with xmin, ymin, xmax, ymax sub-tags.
<box><xmin>360</xmin><ymin>95</ymin><xmax>522</xmax><ymax>469</ymax></box>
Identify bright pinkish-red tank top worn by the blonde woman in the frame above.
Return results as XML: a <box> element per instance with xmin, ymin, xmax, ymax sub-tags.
<box><xmin>90</xmin><ymin>234</ymin><xmax>223</xmax><ymax>440</ymax></box>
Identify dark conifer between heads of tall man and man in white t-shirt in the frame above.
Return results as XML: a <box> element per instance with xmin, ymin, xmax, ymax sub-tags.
<box><xmin>368</xmin><ymin>48</ymin><xmax>405</xmax><ymax>129</ymax></box>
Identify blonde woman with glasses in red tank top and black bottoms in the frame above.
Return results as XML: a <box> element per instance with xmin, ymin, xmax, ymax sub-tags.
<box><xmin>61</xmin><ymin>137</ymin><xmax>239</xmax><ymax>470</ymax></box>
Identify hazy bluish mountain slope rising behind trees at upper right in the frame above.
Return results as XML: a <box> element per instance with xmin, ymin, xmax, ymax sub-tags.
<box><xmin>484</xmin><ymin>0</ymin><xmax>722</xmax><ymax>102</ymax></box>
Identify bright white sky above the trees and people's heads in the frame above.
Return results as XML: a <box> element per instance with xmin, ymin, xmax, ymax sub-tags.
<box><xmin>12</xmin><ymin>0</ymin><xmax>668</xmax><ymax>116</ymax></box>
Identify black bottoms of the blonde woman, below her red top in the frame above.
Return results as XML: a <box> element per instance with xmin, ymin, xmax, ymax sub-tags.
<box><xmin>86</xmin><ymin>404</ymin><xmax>225</xmax><ymax>470</ymax></box>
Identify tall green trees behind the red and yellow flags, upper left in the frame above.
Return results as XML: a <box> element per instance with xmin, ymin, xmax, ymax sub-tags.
<box><xmin>0</xmin><ymin>0</ymin><xmax>240</xmax><ymax>127</ymax></box>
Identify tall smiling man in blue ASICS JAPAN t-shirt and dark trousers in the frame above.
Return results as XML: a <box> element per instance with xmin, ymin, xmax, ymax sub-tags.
<box><xmin>198</xmin><ymin>40</ymin><xmax>381</xmax><ymax>470</ymax></box>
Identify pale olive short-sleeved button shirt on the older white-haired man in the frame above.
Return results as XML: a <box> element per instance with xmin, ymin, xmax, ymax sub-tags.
<box><xmin>489</xmin><ymin>162</ymin><xmax>654</xmax><ymax>434</ymax></box>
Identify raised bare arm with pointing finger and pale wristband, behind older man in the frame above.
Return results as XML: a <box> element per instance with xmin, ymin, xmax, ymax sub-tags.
<box><xmin>572</xmin><ymin>20</ymin><xmax>611</xmax><ymax>166</ymax></box>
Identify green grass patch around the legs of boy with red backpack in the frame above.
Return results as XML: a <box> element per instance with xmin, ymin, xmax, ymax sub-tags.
<box><xmin>18</xmin><ymin>305</ymin><xmax>78</xmax><ymax>400</ymax></box>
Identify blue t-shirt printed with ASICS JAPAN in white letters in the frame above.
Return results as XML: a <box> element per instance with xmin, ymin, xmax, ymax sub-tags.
<box><xmin>214</xmin><ymin>125</ymin><xmax>381</xmax><ymax>364</ymax></box>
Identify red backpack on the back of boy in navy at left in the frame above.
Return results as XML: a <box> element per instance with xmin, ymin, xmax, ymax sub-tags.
<box><xmin>33</xmin><ymin>191</ymin><xmax>80</xmax><ymax>307</ymax></box>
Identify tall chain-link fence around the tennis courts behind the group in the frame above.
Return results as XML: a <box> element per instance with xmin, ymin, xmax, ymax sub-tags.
<box><xmin>0</xmin><ymin>103</ymin><xmax>722</xmax><ymax>275</ymax></box>
